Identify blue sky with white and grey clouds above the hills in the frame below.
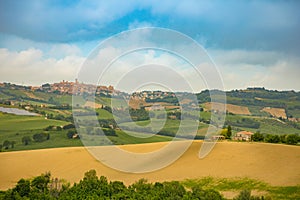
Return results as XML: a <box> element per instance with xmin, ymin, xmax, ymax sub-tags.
<box><xmin>0</xmin><ymin>0</ymin><xmax>300</xmax><ymax>91</ymax></box>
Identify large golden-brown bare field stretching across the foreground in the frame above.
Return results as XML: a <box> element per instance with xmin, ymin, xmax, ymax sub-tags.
<box><xmin>0</xmin><ymin>141</ymin><xmax>300</xmax><ymax>190</ymax></box>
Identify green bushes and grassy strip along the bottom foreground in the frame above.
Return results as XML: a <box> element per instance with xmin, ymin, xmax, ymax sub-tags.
<box><xmin>0</xmin><ymin>170</ymin><xmax>300</xmax><ymax>200</ymax></box>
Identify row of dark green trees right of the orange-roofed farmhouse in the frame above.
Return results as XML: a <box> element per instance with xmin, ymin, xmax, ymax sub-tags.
<box><xmin>252</xmin><ymin>132</ymin><xmax>300</xmax><ymax>145</ymax></box>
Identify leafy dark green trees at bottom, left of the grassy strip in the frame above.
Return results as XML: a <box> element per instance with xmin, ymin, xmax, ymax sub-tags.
<box><xmin>0</xmin><ymin>170</ymin><xmax>224</xmax><ymax>200</ymax></box>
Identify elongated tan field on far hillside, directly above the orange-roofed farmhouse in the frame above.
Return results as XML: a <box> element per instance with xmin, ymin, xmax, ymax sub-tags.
<box><xmin>204</xmin><ymin>102</ymin><xmax>251</xmax><ymax>115</ymax></box>
